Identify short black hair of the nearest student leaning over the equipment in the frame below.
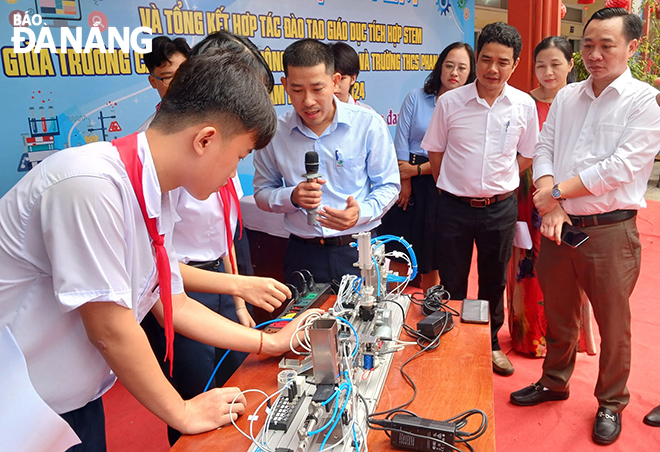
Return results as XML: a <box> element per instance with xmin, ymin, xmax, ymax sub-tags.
<box><xmin>150</xmin><ymin>50</ymin><xmax>277</xmax><ymax>149</ymax></box>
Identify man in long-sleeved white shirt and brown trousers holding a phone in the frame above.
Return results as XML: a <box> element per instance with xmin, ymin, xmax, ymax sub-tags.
<box><xmin>511</xmin><ymin>8</ymin><xmax>660</xmax><ymax>444</ymax></box>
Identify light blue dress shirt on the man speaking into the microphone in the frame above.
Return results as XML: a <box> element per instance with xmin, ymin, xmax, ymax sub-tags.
<box><xmin>253</xmin><ymin>97</ymin><xmax>401</xmax><ymax>238</ymax></box>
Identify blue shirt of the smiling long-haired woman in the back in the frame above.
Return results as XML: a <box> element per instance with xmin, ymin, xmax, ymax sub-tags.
<box><xmin>394</xmin><ymin>88</ymin><xmax>435</xmax><ymax>162</ymax></box>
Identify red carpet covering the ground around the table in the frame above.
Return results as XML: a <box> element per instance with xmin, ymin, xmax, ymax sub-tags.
<box><xmin>104</xmin><ymin>201</ymin><xmax>660</xmax><ymax>452</ymax></box>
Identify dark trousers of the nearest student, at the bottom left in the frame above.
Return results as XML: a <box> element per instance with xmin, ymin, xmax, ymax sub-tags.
<box><xmin>60</xmin><ymin>397</ymin><xmax>106</xmax><ymax>452</ymax></box>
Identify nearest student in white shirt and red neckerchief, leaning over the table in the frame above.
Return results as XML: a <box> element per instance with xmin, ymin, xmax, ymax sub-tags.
<box><xmin>0</xmin><ymin>51</ymin><xmax>320</xmax><ymax>450</ymax></box>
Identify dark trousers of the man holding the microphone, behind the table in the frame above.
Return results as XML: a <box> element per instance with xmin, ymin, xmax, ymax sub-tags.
<box><xmin>283</xmin><ymin>238</ymin><xmax>360</xmax><ymax>292</ymax></box>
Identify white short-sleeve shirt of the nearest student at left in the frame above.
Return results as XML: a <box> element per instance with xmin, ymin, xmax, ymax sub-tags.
<box><xmin>0</xmin><ymin>134</ymin><xmax>183</xmax><ymax>413</ymax></box>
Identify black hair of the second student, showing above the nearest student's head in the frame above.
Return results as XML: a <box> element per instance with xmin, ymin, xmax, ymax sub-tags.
<box><xmin>190</xmin><ymin>30</ymin><xmax>275</xmax><ymax>93</ymax></box>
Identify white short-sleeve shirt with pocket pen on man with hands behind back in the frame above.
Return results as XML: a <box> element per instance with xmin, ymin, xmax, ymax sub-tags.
<box><xmin>421</xmin><ymin>82</ymin><xmax>539</xmax><ymax>198</ymax></box>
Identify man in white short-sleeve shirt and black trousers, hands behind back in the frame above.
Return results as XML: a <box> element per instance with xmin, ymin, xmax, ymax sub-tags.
<box><xmin>422</xmin><ymin>22</ymin><xmax>539</xmax><ymax>375</ymax></box>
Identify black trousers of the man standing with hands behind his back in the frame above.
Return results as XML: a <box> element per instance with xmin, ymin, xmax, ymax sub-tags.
<box><xmin>435</xmin><ymin>193</ymin><xmax>518</xmax><ymax>350</ymax></box>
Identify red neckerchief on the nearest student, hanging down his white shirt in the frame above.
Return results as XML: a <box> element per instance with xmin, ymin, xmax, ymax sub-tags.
<box><xmin>112</xmin><ymin>133</ymin><xmax>174</xmax><ymax>376</ymax></box>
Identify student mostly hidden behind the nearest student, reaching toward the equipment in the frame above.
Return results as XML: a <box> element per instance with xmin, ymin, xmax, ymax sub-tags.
<box><xmin>142</xmin><ymin>30</ymin><xmax>284</xmax><ymax>445</ymax></box>
